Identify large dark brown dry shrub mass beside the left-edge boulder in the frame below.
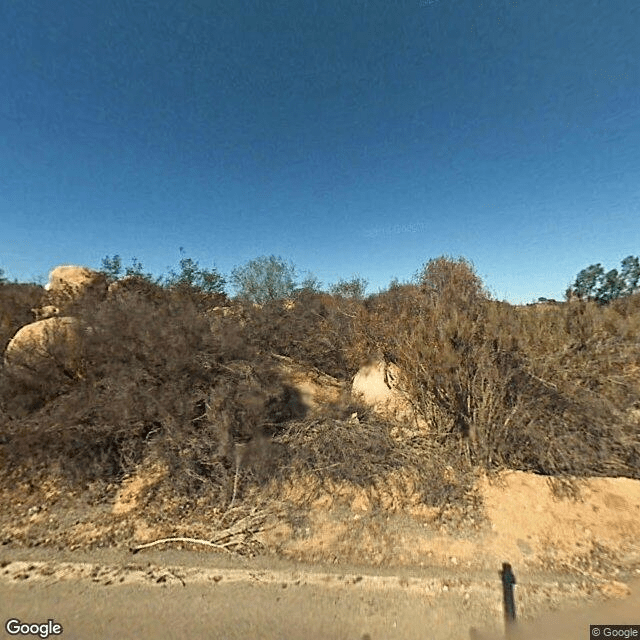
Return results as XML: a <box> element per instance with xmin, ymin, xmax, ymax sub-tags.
<box><xmin>2</xmin><ymin>288</ymin><xmax>302</xmax><ymax>502</ymax></box>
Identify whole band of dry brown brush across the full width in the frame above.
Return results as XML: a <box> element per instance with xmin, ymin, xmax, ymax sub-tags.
<box><xmin>0</xmin><ymin>259</ymin><xmax>640</xmax><ymax>528</ymax></box>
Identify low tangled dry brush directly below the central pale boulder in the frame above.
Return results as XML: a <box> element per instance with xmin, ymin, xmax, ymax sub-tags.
<box><xmin>262</xmin><ymin>404</ymin><xmax>477</xmax><ymax>516</ymax></box>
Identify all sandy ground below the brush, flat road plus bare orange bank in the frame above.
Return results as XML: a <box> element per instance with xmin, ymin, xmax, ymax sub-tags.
<box><xmin>0</xmin><ymin>473</ymin><xmax>640</xmax><ymax>640</ymax></box>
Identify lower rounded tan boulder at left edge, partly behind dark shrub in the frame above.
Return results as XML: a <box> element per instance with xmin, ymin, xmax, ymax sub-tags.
<box><xmin>4</xmin><ymin>317</ymin><xmax>86</xmax><ymax>376</ymax></box>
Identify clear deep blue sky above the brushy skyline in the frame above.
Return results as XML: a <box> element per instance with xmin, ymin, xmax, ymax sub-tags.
<box><xmin>0</xmin><ymin>0</ymin><xmax>640</xmax><ymax>303</ymax></box>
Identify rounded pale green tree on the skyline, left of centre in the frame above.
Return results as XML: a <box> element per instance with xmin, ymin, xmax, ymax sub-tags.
<box><xmin>231</xmin><ymin>255</ymin><xmax>296</xmax><ymax>304</ymax></box>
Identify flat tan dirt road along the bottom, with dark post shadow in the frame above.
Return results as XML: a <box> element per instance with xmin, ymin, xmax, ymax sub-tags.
<box><xmin>0</xmin><ymin>550</ymin><xmax>640</xmax><ymax>640</ymax></box>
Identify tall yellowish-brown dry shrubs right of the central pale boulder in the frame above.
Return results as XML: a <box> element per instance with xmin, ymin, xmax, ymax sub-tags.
<box><xmin>348</xmin><ymin>258</ymin><xmax>640</xmax><ymax>477</ymax></box>
